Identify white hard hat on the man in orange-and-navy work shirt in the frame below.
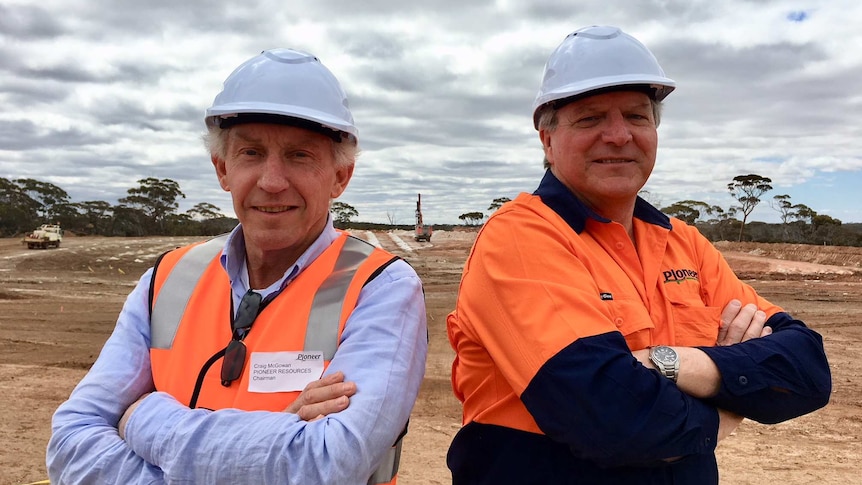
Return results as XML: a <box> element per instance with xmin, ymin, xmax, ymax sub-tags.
<box><xmin>533</xmin><ymin>25</ymin><xmax>676</xmax><ymax>129</ymax></box>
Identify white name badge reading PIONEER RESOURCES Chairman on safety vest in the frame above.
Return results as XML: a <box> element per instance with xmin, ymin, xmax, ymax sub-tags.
<box><xmin>248</xmin><ymin>350</ymin><xmax>323</xmax><ymax>393</ymax></box>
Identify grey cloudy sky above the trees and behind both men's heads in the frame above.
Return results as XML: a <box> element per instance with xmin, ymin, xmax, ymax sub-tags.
<box><xmin>0</xmin><ymin>0</ymin><xmax>862</xmax><ymax>224</ymax></box>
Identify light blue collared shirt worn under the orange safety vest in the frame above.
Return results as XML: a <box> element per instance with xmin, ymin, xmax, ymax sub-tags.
<box><xmin>47</xmin><ymin>221</ymin><xmax>428</xmax><ymax>485</ymax></box>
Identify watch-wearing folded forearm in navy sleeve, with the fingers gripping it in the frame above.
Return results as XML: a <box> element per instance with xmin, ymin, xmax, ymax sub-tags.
<box><xmin>632</xmin><ymin>300</ymin><xmax>832</xmax><ymax>424</ymax></box>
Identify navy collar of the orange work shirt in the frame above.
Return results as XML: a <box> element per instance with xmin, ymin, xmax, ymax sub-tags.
<box><xmin>533</xmin><ymin>169</ymin><xmax>672</xmax><ymax>234</ymax></box>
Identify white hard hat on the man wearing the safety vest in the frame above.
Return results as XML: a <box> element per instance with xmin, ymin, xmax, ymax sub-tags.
<box><xmin>205</xmin><ymin>49</ymin><xmax>358</xmax><ymax>137</ymax></box>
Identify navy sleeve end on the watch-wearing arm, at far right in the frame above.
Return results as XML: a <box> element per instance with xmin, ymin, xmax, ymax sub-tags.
<box><xmin>699</xmin><ymin>312</ymin><xmax>832</xmax><ymax>424</ymax></box>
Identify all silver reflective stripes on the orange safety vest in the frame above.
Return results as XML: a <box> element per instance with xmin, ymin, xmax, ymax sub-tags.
<box><xmin>150</xmin><ymin>235</ymin><xmax>403</xmax><ymax>485</ymax></box>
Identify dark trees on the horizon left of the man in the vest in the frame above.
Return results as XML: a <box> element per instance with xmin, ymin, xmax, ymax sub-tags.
<box><xmin>0</xmin><ymin>177</ymin><xmax>237</xmax><ymax>237</ymax></box>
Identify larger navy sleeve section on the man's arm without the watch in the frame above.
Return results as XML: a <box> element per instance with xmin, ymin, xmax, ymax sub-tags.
<box><xmin>521</xmin><ymin>332</ymin><xmax>719</xmax><ymax>466</ymax></box>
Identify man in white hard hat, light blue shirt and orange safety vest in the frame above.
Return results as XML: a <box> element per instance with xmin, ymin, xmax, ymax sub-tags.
<box><xmin>47</xmin><ymin>49</ymin><xmax>428</xmax><ymax>485</ymax></box>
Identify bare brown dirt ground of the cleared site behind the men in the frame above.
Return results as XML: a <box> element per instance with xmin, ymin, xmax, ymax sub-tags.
<box><xmin>0</xmin><ymin>231</ymin><xmax>862</xmax><ymax>485</ymax></box>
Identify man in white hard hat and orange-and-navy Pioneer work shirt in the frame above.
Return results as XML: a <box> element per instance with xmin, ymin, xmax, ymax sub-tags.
<box><xmin>447</xmin><ymin>26</ymin><xmax>831</xmax><ymax>485</ymax></box>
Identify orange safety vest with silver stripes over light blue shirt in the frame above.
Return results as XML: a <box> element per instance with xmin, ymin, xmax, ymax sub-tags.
<box><xmin>150</xmin><ymin>233</ymin><xmax>406</xmax><ymax>484</ymax></box>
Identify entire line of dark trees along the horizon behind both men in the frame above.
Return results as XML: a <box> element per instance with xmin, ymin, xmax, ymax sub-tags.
<box><xmin>0</xmin><ymin>174</ymin><xmax>862</xmax><ymax>246</ymax></box>
